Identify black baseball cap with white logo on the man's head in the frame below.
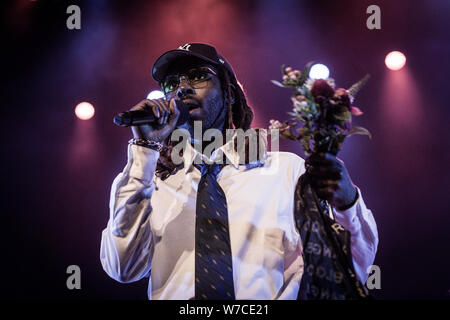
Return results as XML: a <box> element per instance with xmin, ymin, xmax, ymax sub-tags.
<box><xmin>152</xmin><ymin>43</ymin><xmax>235</xmax><ymax>83</ymax></box>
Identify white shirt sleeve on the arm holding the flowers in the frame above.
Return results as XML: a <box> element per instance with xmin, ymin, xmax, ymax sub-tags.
<box><xmin>333</xmin><ymin>188</ymin><xmax>378</xmax><ymax>283</ymax></box>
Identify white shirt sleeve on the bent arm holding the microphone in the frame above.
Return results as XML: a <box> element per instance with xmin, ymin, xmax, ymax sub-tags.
<box><xmin>100</xmin><ymin>144</ymin><xmax>159</xmax><ymax>282</ymax></box>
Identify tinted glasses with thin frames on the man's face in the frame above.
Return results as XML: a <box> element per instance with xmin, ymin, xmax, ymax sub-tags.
<box><xmin>161</xmin><ymin>67</ymin><xmax>217</xmax><ymax>94</ymax></box>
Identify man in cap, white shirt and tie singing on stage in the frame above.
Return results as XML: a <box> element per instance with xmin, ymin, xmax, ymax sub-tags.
<box><xmin>100</xmin><ymin>43</ymin><xmax>378</xmax><ymax>300</ymax></box>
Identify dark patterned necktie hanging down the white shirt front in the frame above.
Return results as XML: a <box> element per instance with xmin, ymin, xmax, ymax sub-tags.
<box><xmin>195</xmin><ymin>163</ymin><xmax>235</xmax><ymax>300</ymax></box>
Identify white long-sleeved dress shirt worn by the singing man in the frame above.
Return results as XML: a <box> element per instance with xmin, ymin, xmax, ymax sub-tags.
<box><xmin>100</xmin><ymin>141</ymin><xmax>378</xmax><ymax>300</ymax></box>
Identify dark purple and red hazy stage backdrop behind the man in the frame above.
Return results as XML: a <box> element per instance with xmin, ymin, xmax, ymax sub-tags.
<box><xmin>0</xmin><ymin>0</ymin><xmax>450</xmax><ymax>299</ymax></box>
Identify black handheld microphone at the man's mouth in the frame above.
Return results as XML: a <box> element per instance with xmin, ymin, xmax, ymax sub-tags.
<box><xmin>113</xmin><ymin>100</ymin><xmax>189</xmax><ymax>127</ymax></box>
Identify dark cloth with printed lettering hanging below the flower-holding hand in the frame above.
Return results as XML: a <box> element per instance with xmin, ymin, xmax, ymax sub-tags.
<box><xmin>294</xmin><ymin>174</ymin><xmax>371</xmax><ymax>300</ymax></box>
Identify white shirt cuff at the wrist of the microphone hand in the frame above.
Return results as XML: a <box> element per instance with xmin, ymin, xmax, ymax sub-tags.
<box><xmin>127</xmin><ymin>144</ymin><xmax>159</xmax><ymax>181</ymax></box>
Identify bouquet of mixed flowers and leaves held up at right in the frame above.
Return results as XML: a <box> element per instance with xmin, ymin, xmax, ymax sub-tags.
<box><xmin>269</xmin><ymin>62</ymin><xmax>371</xmax><ymax>156</ymax></box>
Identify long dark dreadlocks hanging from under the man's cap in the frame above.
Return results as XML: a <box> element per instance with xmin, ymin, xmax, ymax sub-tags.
<box><xmin>155</xmin><ymin>69</ymin><xmax>253</xmax><ymax>180</ymax></box>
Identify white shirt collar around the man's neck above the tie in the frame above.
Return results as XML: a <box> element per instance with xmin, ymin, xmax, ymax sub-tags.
<box><xmin>183</xmin><ymin>133</ymin><xmax>267</xmax><ymax>173</ymax></box>
